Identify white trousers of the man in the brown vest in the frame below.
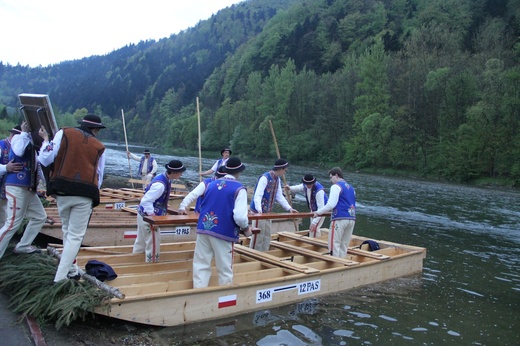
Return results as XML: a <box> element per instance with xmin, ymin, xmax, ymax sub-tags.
<box><xmin>54</xmin><ymin>195</ymin><xmax>92</xmax><ymax>282</ymax></box>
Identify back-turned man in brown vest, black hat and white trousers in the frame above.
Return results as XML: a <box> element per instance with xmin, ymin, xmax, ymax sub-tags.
<box><xmin>39</xmin><ymin>114</ymin><xmax>106</xmax><ymax>282</ymax></box>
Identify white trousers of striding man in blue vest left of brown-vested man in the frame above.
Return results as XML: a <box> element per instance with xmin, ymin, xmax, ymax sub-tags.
<box><xmin>0</xmin><ymin>185</ymin><xmax>47</xmax><ymax>258</ymax></box>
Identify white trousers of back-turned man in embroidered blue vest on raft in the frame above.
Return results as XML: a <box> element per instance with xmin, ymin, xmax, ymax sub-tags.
<box><xmin>193</xmin><ymin>234</ymin><xmax>234</xmax><ymax>288</ymax></box>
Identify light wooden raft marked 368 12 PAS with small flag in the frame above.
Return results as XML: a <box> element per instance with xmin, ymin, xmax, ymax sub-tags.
<box><xmin>61</xmin><ymin>233</ymin><xmax>426</xmax><ymax>327</ymax></box>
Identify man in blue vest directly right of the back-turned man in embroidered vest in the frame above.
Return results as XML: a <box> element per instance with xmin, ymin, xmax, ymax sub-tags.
<box><xmin>249</xmin><ymin>159</ymin><xmax>298</xmax><ymax>251</ymax></box>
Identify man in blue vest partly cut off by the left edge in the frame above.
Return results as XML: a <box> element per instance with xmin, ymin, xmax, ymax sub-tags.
<box><xmin>0</xmin><ymin>125</ymin><xmax>22</xmax><ymax>227</ymax></box>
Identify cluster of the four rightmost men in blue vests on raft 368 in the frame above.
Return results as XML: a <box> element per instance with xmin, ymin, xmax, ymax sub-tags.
<box><xmin>169</xmin><ymin>149</ymin><xmax>356</xmax><ymax>288</ymax></box>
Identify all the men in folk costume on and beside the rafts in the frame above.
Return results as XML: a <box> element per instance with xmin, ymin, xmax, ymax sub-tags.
<box><xmin>0</xmin><ymin>119</ymin><xmax>356</xmax><ymax>288</ymax></box>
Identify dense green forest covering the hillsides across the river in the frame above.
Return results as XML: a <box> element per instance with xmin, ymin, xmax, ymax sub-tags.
<box><xmin>0</xmin><ymin>0</ymin><xmax>520</xmax><ymax>185</ymax></box>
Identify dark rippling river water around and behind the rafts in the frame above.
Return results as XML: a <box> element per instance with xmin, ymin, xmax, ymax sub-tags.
<box><xmin>102</xmin><ymin>146</ymin><xmax>520</xmax><ymax>345</ymax></box>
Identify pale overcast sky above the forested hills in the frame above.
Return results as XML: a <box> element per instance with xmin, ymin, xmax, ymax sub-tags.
<box><xmin>0</xmin><ymin>0</ymin><xmax>241</xmax><ymax>67</ymax></box>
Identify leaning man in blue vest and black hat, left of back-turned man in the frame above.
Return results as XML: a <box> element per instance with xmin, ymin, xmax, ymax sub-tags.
<box><xmin>132</xmin><ymin>160</ymin><xmax>186</xmax><ymax>262</ymax></box>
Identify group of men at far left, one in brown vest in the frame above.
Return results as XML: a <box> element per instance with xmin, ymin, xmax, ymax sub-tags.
<box><xmin>0</xmin><ymin>114</ymin><xmax>105</xmax><ymax>282</ymax></box>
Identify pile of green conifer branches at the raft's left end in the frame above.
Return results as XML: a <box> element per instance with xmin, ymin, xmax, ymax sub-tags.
<box><xmin>0</xmin><ymin>249</ymin><xmax>109</xmax><ymax>329</ymax></box>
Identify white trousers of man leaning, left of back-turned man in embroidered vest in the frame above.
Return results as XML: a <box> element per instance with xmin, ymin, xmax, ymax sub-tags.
<box><xmin>132</xmin><ymin>214</ymin><xmax>161</xmax><ymax>262</ymax></box>
